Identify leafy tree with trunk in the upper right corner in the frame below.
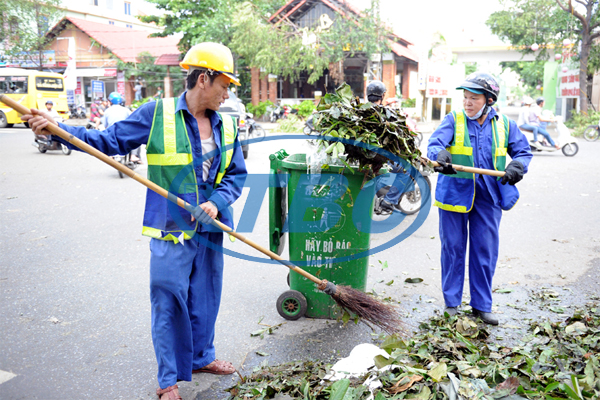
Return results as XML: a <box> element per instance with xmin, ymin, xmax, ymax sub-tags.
<box><xmin>487</xmin><ymin>0</ymin><xmax>600</xmax><ymax>112</ymax></box>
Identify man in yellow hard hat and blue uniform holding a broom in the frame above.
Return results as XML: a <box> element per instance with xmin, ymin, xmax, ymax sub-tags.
<box><xmin>23</xmin><ymin>43</ymin><xmax>247</xmax><ymax>400</ymax></box>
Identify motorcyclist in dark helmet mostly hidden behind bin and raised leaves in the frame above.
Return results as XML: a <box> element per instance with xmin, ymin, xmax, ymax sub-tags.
<box><xmin>367</xmin><ymin>80</ymin><xmax>410</xmax><ymax>215</ymax></box>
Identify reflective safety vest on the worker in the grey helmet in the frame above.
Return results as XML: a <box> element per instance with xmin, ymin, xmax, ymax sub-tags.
<box><xmin>434</xmin><ymin>111</ymin><xmax>510</xmax><ymax>213</ymax></box>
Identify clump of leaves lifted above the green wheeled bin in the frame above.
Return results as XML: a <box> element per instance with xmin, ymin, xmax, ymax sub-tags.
<box><xmin>314</xmin><ymin>83</ymin><xmax>421</xmax><ymax>174</ymax></box>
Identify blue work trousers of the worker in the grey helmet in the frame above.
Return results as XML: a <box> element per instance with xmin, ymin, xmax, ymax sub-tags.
<box><xmin>439</xmin><ymin>176</ymin><xmax>502</xmax><ymax>312</ymax></box>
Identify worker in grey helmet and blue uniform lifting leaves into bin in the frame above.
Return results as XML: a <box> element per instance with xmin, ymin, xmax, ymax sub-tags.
<box><xmin>427</xmin><ymin>72</ymin><xmax>532</xmax><ymax>325</ymax></box>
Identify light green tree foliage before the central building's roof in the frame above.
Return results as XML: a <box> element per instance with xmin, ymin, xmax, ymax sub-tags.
<box><xmin>231</xmin><ymin>2</ymin><xmax>388</xmax><ymax>84</ymax></box>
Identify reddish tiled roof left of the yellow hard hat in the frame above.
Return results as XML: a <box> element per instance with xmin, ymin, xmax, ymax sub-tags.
<box><xmin>47</xmin><ymin>17</ymin><xmax>179</xmax><ymax>62</ymax></box>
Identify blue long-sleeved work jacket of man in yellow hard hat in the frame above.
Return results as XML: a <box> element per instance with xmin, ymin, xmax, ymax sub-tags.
<box><xmin>55</xmin><ymin>91</ymin><xmax>248</xmax><ymax>232</ymax></box>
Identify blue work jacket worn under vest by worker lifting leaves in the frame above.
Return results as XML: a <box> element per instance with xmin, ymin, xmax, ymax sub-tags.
<box><xmin>427</xmin><ymin>108</ymin><xmax>533</xmax><ymax>209</ymax></box>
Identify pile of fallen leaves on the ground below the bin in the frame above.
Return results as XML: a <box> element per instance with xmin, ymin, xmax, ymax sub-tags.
<box><xmin>227</xmin><ymin>303</ymin><xmax>600</xmax><ymax>400</ymax></box>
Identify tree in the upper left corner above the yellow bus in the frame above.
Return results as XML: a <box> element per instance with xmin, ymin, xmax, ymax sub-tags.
<box><xmin>0</xmin><ymin>0</ymin><xmax>63</xmax><ymax>70</ymax></box>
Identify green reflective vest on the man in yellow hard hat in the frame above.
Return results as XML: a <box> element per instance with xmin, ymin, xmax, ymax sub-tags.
<box><xmin>142</xmin><ymin>98</ymin><xmax>237</xmax><ymax>243</ymax></box>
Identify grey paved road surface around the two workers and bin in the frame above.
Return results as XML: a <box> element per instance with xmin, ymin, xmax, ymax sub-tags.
<box><xmin>0</xmin><ymin>119</ymin><xmax>600</xmax><ymax>400</ymax></box>
